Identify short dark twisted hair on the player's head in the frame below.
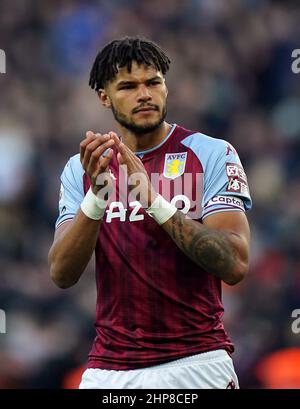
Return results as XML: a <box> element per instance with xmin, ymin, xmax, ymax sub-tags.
<box><xmin>89</xmin><ymin>37</ymin><xmax>171</xmax><ymax>91</ymax></box>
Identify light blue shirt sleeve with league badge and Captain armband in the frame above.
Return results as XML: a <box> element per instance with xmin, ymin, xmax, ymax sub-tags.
<box><xmin>185</xmin><ymin>134</ymin><xmax>252</xmax><ymax>219</ymax></box>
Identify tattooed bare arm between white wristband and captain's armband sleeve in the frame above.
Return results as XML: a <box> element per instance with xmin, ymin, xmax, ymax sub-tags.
<box><xmin>161</xmin><ymin>210</ymin><xmax>250</xmax><ymax>285</ymax></box>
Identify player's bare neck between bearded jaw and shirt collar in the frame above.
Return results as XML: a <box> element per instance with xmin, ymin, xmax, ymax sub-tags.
<box><xmin>119</xmin><ymin>121</ymin><xmax>171</xmax><ymax>152</ymax></box>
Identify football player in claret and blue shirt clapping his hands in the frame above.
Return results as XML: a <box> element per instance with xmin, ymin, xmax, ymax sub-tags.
<box><xmin>49</xmin><ymin>37</ymin><xmax>251</xmax><ymax>389</ymax></box>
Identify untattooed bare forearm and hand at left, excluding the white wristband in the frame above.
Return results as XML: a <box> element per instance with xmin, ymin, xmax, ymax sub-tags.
<box><xmin>48</xmin><ymin>132</ymin><xmax>114</xmax><ymax>288</ymax></box>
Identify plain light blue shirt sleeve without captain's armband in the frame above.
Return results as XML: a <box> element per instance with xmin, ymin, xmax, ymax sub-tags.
<box><xmin>55</xmin><ymin>155</ymin><xmax>84</xmax><ymax>229</ymax></box>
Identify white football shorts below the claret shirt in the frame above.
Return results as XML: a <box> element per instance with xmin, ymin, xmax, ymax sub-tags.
<box><xmin>79</xmin><ymin>349</ymin><xmax>239</xmax><ymax>389</ymax></box>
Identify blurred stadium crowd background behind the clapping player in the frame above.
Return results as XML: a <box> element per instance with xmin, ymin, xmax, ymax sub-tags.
<box><xmin>0</xmin><ymin>0</ymin><xmax>300</xmax><ymax>388</ymax></box>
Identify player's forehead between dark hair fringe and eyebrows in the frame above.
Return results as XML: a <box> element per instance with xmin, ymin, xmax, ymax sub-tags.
<box><xmin>112</xmin><ymin>61</ymin><xmax>163</xmax><ymax>83</ymax></box>
